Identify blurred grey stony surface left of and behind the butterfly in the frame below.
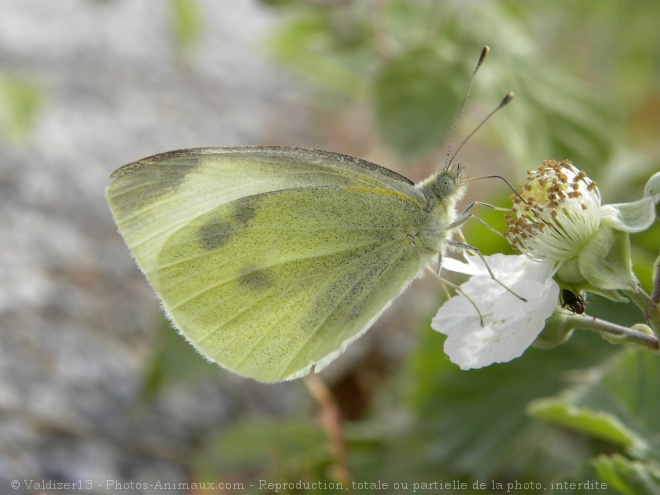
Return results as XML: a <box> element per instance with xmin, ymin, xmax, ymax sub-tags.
<box><xmin>0</xmin><ymin>0</ymin><xmax>316</xmax><ymax>494</ymax></box>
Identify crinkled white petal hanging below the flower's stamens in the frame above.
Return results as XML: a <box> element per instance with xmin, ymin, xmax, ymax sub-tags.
<box><xmin>431</xmin><ymin>254</ymin><xmax>559</xmax><ymax>369</ymax></box>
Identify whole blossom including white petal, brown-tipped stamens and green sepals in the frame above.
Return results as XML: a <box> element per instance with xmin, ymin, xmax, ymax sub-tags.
<box><xmin>431</xmin><ymin>165</ymin><xmax>660</xmax><ymax>369</ymax></box>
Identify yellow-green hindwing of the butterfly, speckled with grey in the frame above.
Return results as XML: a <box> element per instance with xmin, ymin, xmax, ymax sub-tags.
<box><xmin>155</xmin><ymin>188</ymin><xmax>421</xmax><ymax>381</ymax></box>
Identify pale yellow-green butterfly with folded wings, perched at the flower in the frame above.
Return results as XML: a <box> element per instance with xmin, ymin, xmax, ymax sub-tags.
<box><xmin>107</xmin><ymin>46</ymin><xmax>502</xmax><ymax>382</ymax></box>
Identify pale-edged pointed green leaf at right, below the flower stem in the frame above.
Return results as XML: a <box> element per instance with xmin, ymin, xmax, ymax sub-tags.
<box><xmin>529</xmin><ymin>350</ymin><xmax>660</xmax><ymax>460</ymax></box>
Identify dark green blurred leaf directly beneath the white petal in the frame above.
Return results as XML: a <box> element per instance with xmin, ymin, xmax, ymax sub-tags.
<box><xmin>412</xmin><ymin>326</ymin><xmax>611</xmax><ymax>478</ymax></box>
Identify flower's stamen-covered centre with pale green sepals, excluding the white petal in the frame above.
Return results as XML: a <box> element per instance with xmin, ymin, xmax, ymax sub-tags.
<box><xmin>504</xmin><ymin>160</ymin><xmax>660</xmax><ymax>301</ymax></box>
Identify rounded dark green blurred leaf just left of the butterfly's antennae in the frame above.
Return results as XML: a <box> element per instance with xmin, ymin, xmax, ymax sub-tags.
<box><xmin>373</xmin><ymin>47</ymin><xmax>468</xmax><ymax>156</ymax></box>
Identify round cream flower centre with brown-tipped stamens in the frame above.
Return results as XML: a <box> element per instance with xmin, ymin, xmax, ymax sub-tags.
<box><xmin>504</xmin><ymin>160</ymin><xmax>601</xmax><ymax>263</ymax></box>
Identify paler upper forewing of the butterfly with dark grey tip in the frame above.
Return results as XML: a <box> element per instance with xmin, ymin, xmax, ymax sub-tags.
<box><xmin>107</xmin><ymin>147</ymin><xmax>415</xmax><ymax>276</ymax></box>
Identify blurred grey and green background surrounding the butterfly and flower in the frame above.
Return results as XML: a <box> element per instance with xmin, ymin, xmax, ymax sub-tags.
<box><xmin>0</xmin><ymin>0</ymin><xmax>660</xmax><ymax>494</ymax></box>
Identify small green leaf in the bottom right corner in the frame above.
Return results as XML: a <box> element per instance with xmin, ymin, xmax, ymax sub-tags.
<box><xmin>593</xmin><ymin>455</ymin><xmax>660</xmax><ymax>495</ymax></box>
